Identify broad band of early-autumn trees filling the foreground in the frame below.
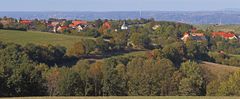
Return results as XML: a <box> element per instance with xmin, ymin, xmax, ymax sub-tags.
<box><xmin>0</xmin><ymin>39</ymin><xmax>239</xmax><ymax>96</ymax></box>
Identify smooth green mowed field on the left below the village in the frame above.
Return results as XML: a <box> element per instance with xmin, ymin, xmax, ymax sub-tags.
<box><xmin>0</xmin><ymin>30</ymin><xmax>94</xmax><ymax>48</ymax></box>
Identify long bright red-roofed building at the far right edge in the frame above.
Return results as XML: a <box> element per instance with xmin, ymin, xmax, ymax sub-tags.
<box><xmin>212</xmin><ymin>32</ymin><xmax>238</xmax><ymax>40</ymax></box>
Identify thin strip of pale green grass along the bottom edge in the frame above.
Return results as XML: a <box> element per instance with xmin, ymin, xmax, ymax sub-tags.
<box><xmin>2</xmin><ymin>96</ymin><xmax>240</xmax><ymax>99</ymax></box>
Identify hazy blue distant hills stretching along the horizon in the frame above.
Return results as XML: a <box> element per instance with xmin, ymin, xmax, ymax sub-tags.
<box><xmin>0</xmin><ymin>9</ymin><xmax>240</xmax><ymax>24</ymax></box>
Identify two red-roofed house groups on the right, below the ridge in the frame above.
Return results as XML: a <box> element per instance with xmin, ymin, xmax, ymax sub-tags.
<box><xmin>181</xmin><ymin>29</ymin><xmax>240</xmax><ymax>42</ymax></box>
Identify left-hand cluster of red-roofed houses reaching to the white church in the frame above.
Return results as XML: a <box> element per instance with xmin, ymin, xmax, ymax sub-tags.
<box><xmin>0</xmin><ymin>18</ymin><xmax>130</xmax><ymax>33</ymax></box>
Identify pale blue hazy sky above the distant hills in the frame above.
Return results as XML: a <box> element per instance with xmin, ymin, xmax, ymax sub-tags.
<box><xmin>0</xmin><ymin>0</ymin><xmax>240</xmax><ymax>11</ymax></box>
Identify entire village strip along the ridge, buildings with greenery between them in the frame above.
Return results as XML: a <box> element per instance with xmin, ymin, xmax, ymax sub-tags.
<box><xmin>0</xmin><ymin>18</ymin><xmax>240</xmax><ymax>42</ymax></box>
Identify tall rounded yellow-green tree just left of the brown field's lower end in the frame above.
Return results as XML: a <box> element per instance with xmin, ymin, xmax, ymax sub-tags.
<box><xmin>179</xmin><ymin>61</ymin><xmax>205</xmax><ymax>96</ymax></box>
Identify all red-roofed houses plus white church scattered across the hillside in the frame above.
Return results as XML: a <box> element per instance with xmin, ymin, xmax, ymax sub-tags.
<box><xmin>0</xmin><ymin>19</ymin><xmax>240</xmax><ymax>42</ymax></box>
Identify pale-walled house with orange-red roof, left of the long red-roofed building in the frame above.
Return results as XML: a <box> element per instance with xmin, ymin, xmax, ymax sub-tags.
<box><xmin>181</xmin><ymin>32</ymin><xmax>207</xmax><ymax>42</ymax></box>
